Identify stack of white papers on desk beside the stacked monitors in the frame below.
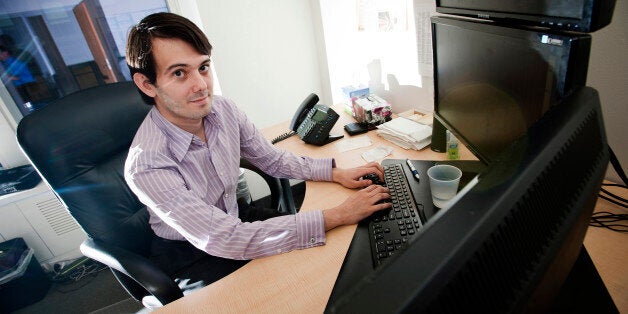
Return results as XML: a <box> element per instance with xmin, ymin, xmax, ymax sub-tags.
<box><xmin>377</xmin><ymin>117</ymin><xmax>432</xmax><ymax>150</ymax></box>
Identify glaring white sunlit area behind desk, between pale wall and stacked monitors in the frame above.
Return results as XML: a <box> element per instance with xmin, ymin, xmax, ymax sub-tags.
<box><xmin>320</xmin><ymin>0</ymin><xmax>435</xmax><ymax>112</ymax></box>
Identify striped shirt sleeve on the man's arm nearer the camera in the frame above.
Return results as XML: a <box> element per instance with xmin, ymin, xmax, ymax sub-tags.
<box><xmin>125</xmin><ymin>147</ymin><xmax>325</xmax><ymax>260</ymax></box>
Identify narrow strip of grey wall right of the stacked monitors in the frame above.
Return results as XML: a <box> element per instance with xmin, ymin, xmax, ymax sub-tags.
<box><xmin>587</xmin><ymin>0</ymin><xmax>628</xmax><ymax>182</ymax></box>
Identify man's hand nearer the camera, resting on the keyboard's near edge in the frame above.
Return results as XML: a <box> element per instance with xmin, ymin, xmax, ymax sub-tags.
<box><xmin>323</xmin><ymin>185</ymin><xmax>391</xmax><ymax>231</ymax></box>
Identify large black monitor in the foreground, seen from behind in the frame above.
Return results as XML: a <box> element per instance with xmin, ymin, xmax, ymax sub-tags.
<box><xmin>326</xmin><ymin>87</ymin><xmax>609</xmax><ymax>313</ymax></box>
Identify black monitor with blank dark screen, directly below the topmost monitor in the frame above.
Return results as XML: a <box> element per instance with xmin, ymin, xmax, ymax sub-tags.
<box><xmin>432</xmin><ymin>17</ymin><xmax>591</xmax><ymax>163</ymax></box>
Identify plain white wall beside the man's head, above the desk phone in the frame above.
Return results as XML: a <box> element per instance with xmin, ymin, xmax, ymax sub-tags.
<box><xmin>197</xmin><ymin>0</ymin><xmax>324</xmax><ymax>128</ymax></box>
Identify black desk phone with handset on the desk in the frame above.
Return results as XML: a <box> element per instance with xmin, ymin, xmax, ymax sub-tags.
<box><xmin>272</xmin><ymin>93</ymin><xmax>343</xmax><ymax>146</ymax></box>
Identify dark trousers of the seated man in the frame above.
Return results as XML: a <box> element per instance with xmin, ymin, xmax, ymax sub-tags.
<box><xmin>150</xmin><ymin>202</ymin><xmax>282</xmax><ymax>290</ymax></box>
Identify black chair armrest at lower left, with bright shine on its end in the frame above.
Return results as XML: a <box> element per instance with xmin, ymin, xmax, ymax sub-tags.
<box><xmin>80</xmin><ymin>238</ymin><xmax>183</xmax><ymax>304</ymax></box>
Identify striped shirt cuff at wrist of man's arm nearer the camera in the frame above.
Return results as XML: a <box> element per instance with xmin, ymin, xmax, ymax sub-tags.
<box><xmin>296</xmin><ymin>210</ymin><xmax>325</xmax><ymax>249</ymax></box>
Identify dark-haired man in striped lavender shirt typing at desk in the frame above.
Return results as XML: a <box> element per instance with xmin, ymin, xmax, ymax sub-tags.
<box><xmin>125</xmin><ymin>13</ymin><xmax>390</xmax><ymax>283</ymax></box>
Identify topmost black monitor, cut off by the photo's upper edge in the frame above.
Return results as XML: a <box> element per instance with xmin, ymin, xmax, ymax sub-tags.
<box><xmin>436</xmin><ymin>0</ymin><xmax>615</xmax><ymax>32</ymax></box>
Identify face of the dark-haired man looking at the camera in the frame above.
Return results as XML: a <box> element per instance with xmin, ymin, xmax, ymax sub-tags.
<box><xmin>136</xmin><ymin>38</ymin><xmax>213</xmax><ymax>125</ymax></box>
